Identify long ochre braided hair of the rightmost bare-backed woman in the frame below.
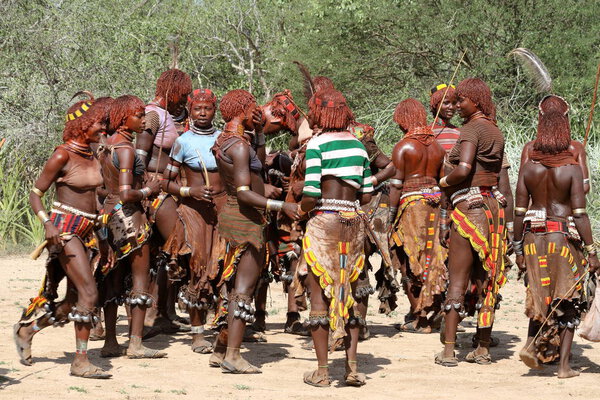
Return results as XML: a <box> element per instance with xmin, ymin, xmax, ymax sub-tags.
<box><xmin>533</xmin><ymin>96</ymin><xmax>571</xmax><ymax>154</ymax></box>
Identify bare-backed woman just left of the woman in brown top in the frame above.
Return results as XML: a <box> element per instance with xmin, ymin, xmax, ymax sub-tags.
<box><xmin>390</xmin><ymin>99</ymin><xmax>448</xmax><ymax>333</ymax></box>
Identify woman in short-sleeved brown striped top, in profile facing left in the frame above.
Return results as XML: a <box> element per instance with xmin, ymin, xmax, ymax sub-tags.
<box><xmin>435</xmin><ymin>78</ymin><xmax>507</xmax><ymax>367</ymax></box>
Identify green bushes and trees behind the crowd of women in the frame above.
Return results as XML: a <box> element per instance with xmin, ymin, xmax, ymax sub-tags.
<box><xmin>0</xmin><ymin>0</ymin><xmax>600</xmax><ymax>249</ymax></box>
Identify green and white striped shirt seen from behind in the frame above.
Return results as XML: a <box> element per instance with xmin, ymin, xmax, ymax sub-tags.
<box><xmin>303</xmin><ymin>132</ymin><xmax>373</xmax><ymax>197</ymax></box>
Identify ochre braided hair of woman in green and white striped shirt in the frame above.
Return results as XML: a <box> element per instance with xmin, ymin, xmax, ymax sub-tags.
<box><xmin>308</xmin><ymin>88</ymin><xmax>354</xmax><ymax>131</ymax></box>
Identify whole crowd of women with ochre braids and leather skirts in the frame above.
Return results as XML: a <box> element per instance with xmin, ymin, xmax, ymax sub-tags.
<box><xmin>14</xmin><ymin>69</ymin><xmax>600</xmax><ymax>387</ymax></box>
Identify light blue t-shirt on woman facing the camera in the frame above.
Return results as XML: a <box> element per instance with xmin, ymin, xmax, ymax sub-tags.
<box><xmin>171</xmin><ymin>129</ymin><xmax>221</xmax><ymax>171</ymax></box>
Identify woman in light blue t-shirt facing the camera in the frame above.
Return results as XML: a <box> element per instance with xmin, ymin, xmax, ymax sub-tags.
<box><xmin>163</xmin><ymin>89</ymin><xmax>226</xmax><ymax>353</ymax></box>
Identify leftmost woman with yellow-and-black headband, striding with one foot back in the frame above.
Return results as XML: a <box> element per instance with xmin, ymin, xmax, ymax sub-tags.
<box><xmin>15</xmin><ymin>93</ymin><xmax>111</xmax><ymax>378</ymax></box>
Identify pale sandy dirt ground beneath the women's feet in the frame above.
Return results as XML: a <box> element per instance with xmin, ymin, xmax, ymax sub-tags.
<box><xmin>0</xmin><ymin>257</ymin><xmax>600</xmax><ymax>400</ymax></box>
